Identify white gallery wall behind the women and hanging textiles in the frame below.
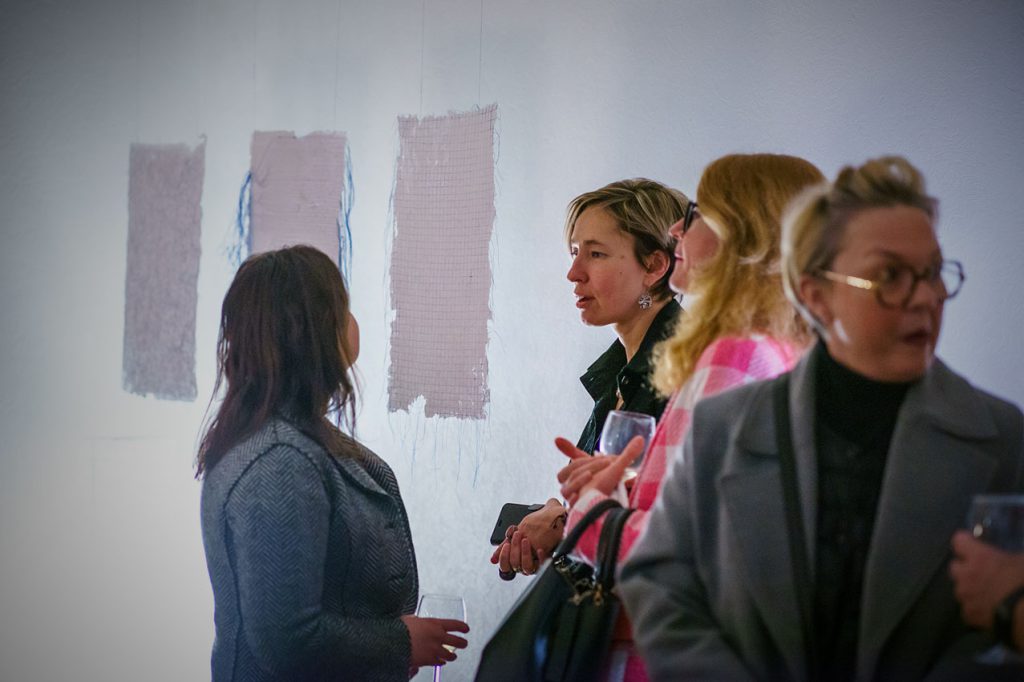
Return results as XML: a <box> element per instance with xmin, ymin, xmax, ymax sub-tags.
<box><xmin>0</xmin><ymin>0</ymin><xmax>1024</xmax><ymax>682</ymax></box>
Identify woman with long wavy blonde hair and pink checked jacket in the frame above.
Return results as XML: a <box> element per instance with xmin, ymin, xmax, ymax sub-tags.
<box><xmin>557</xmin><ymin>154</ymin><xmax>824</xmax><ymax>680</ymax></box>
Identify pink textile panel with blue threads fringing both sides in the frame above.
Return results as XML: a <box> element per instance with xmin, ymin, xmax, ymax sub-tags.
<box><xmin>249</xmin><ymin>131</ymin><xmax>346</xmax><ymax>263</ymax></box>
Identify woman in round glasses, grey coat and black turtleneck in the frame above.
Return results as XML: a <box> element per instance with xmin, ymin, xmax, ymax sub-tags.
<box><xmin>620</xmin><ymin>157</ymin><xmax>1024</xmax><ymax>680</ymax></box>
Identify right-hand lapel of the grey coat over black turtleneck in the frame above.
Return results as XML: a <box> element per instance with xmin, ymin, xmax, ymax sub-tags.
<box><xmin>857</xmin><ymin>360</ymin><xmax>996</xmax><ymax>679</ymax></box>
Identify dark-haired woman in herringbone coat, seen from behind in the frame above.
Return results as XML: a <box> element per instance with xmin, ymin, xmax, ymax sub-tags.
<box><xmin>197</xmin><ymin>246</ymin><xmax>469</xmax><ymax>681</ymax></box>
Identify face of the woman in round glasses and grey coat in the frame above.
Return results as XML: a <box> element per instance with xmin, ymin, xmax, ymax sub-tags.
<box><xmin>802</xmin><ymin>206</ymin><xmax>944</xmax><ymax>382</ymax></box>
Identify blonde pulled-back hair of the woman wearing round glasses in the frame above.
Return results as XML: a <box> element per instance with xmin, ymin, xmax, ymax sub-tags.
<box><xmin>782</xmin><ymin>157</ymin><xmax>938</xmax><ymax>334</ymax></box>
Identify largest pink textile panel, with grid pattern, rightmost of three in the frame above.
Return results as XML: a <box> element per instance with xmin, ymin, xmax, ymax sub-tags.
<box><xmin>388</xmin><ymin>104</ymin><xmax>498</xmax><ymax>419</ymax></box>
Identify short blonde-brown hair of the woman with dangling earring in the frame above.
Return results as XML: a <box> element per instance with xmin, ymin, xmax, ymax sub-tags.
<box><xmin>564</xmin><ymin>177</ymin><xmax>690</xmax><ymax>300</ymax></box>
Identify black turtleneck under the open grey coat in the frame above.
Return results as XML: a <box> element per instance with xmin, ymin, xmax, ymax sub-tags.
<box><xmin>813</xmin><ymin>343</ymin><xmax>910</xmax><ymax>680</ymax></box>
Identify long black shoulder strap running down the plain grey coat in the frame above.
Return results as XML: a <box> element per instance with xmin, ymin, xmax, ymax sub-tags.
<box><xmin>772</xmin><ymin>374</ymin><xmax>818</xmax><ymax>680</ymax></box>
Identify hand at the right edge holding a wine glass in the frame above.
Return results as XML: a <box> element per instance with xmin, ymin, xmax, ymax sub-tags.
<box><xmin>949</xmin><ymin>530</ymin><xmax>1024</xmax><ymax>629</ymax></box>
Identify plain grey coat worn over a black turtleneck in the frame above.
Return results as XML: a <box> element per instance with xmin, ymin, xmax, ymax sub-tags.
<box><xmin>618</xmin><ymin>353</ymin><xmax>1024</xmax><ymax>682</ymax></box>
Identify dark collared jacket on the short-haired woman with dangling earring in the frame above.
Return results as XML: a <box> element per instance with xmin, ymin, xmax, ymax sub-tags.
<box><xmin>577</xmin><ymin>299</ymin><xmax>682</xmax><ymax>453</ymax></box>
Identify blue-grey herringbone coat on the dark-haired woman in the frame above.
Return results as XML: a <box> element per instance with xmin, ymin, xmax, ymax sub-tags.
<box><xmin>202</xmin><ymin>419</ymin><xmax>418</xmax><ymax>682</ymax></box>
